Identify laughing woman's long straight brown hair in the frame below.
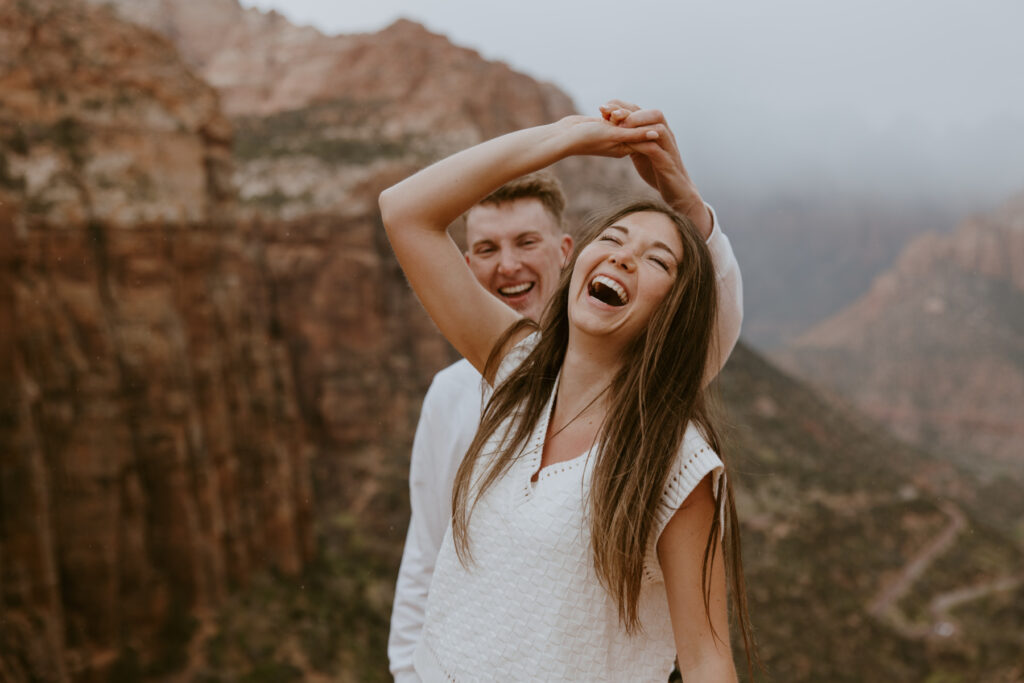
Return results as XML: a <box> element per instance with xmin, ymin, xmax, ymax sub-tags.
<box><xmin>452</xmin><ymin>201</ymin><xmax>756</xmax><ymax>669</ymax></box>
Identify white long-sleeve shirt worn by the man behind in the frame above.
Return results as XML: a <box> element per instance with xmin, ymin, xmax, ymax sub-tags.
<box><xmin>387</xmin><ymin>211</ymin><xmax>743</xmax><ymax>683</ymax></box>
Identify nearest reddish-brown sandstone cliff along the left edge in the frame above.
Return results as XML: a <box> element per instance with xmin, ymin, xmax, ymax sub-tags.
<box><xmin>0</xmin><ymin>0</ymin><xmax>312</xmax><ymax>681</ymax></box>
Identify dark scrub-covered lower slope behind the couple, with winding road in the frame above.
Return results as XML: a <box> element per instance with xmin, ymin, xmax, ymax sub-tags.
<box><xmin>178</xmin><ymin>344</ymin><xmax>1024</xmax><ymax>683</ymax></box>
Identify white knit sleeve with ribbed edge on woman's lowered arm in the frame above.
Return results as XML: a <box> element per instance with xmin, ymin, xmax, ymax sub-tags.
<box><xmin>644</xmin><ymin>424</ymin><xmax>725</xmax><ymax>582</ymax></box>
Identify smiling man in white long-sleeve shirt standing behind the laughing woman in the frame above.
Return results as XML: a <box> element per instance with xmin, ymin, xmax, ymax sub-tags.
<box><xmin>388</xmin><ymin>100</ymin><xmax>742</xmax><ymax>683</ymax></box>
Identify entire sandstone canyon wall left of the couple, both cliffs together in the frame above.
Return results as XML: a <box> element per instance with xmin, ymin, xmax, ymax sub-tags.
<box><xmin>0</xmin><ymin>0</ymin><xmax>626</xmax><ymax>680</ymax></box>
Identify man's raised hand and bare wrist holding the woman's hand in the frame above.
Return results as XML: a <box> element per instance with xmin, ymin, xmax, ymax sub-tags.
<box><xmin>600</xmin><ymin>99</ymin><xmax>713</xmax><ymax>239</ymax></box>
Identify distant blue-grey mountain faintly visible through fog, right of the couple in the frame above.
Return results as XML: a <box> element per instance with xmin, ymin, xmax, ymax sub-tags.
<box><xmin>707</xmin><ymin>194</ymin><xmax>963</xmax><ymax>352</ymax></box>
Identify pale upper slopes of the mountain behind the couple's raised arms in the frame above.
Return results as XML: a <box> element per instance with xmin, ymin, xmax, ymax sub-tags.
<box><xmin>81</xmin><ymin>0</ymin><xmax>643</xmax><ymax>219</ymax></box>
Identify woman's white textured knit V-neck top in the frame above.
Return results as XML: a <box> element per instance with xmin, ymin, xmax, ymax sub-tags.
<box><xmin>415</xmin><ymin>334</ymin><xmax>724</xmax><ymax>683</ymax></box>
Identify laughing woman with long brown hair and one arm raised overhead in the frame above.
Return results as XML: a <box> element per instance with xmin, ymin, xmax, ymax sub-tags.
<box><xmin>381</xmin><ymin>103</ymin><xmax>751</xmax><ymax>683</ymax></box>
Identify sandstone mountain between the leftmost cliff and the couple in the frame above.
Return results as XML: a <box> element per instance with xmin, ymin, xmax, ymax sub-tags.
<box><xmin>79</xmin><ymin>0</ymin><xmax>642</xmax><ymax>553</ymax></box>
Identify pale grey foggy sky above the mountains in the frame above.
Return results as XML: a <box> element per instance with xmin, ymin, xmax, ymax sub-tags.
<box><xmin>243</xmin><ymin>0</ymin><xmax>1024</xmax><ymax>206</ymax></box>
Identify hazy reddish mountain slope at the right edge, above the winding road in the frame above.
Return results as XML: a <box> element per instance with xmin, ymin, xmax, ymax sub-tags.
<box><xmin>784</xmin><ymin>196</ymin><xmax>1024</xmax><ymax>472</ymax></box>
